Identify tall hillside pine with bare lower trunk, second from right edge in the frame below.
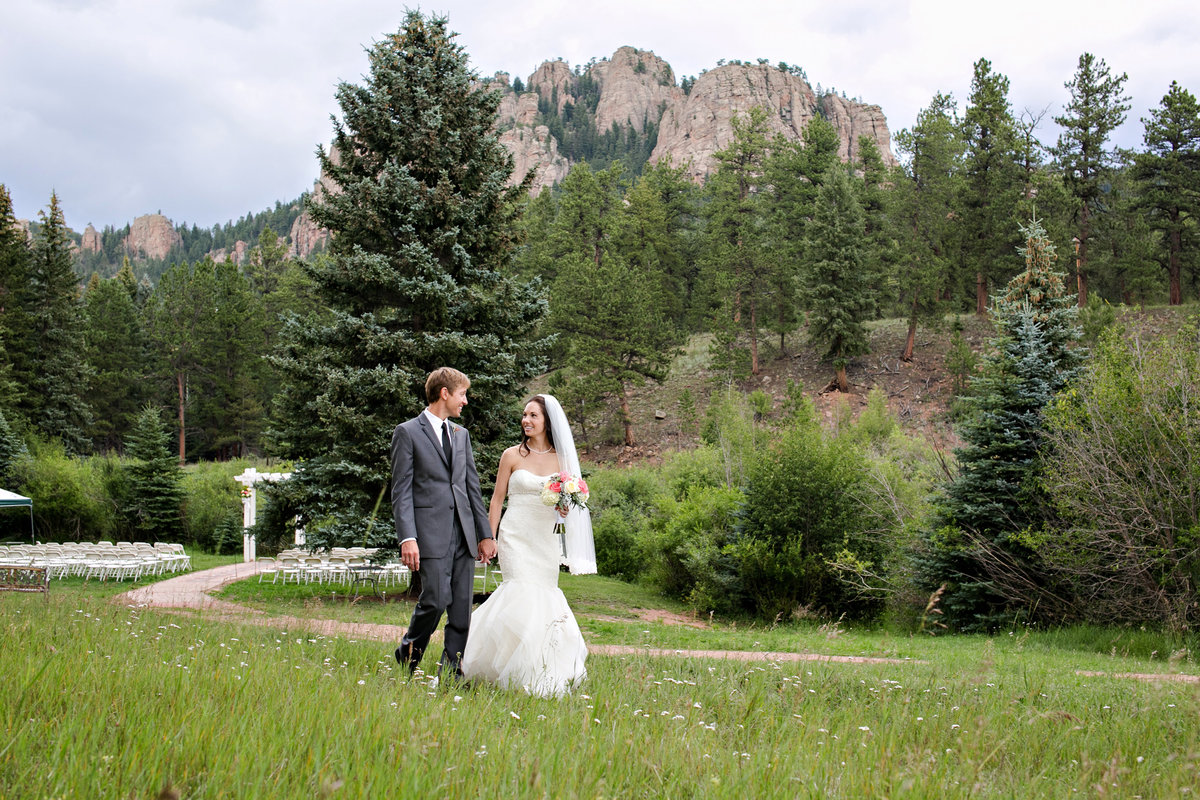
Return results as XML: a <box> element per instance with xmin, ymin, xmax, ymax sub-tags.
<box><xmin>1054</xmin><ymin>53</ymin><xmax>1129</xmax><ymax>306</ymax></box>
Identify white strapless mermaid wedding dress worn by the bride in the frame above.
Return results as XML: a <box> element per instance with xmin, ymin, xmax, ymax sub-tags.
<box><xmin>462</xmin><ymin>469</ymin><xmax>588</xmax><ymax>697</ymax></box>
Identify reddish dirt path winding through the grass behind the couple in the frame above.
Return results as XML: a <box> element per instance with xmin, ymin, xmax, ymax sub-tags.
<box><xmin>115</xmin><ymin>564</ymin><xmax>1200</xmax><ymax>684</ymax></box>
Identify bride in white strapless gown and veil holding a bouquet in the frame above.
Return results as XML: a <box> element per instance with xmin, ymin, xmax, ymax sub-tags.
<box><xmin>462</xmin><ymin>395</ymin><xmax>596</xmax><ymax>697</ymax></box>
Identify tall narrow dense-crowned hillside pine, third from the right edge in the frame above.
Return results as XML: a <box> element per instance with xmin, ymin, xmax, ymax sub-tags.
<box><xmin>959</xmin><ymin>59</ymin><xmax>1022</xmax><ymax>315</ymax></box>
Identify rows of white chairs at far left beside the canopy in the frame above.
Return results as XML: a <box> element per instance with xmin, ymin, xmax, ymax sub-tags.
<box><xmin>0</xmin><ymin>541</ymin><xmax>192</xmax><ymax>581</ymax></box>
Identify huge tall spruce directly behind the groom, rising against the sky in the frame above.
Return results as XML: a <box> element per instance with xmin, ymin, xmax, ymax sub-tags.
<box><xmin>274</xmin><ymin>12</ymin><xmax>546</xmax><ymax>547</ymax></box>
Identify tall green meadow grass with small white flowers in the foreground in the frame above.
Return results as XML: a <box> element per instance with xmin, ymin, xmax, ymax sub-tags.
<box><xmin>0</xmin><ymin>593</ymin><xmax>1200</xmax><ymax>798</ymax></box>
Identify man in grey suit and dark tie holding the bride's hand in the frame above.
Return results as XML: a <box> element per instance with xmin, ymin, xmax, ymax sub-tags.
<box><xmin>391</xmin><ymin>367</ymin><xmax>496</xmax><ymax>674</ymax></box>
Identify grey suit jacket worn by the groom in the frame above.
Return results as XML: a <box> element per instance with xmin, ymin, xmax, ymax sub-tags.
<box><xmin>391</xmin><ymin>414</ymin><xmax>492</xmax><ymax>559</ymax></box>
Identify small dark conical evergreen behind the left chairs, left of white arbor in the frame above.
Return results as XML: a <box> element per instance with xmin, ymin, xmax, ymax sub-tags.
<box><xmin>125</xmin><ymin>405</ymin><xmax>184</xmax><ymax>542</ymax></box>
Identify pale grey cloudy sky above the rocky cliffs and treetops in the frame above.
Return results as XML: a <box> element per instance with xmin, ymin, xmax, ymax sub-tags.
<box><xmin>0</xmin><ymin>0</ymin><xmax>1200</xmax><ymax>230</ymax></box>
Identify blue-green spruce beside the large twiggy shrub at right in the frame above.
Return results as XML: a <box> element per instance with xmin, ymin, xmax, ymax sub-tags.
<box><xmin>918</xmin><ymin>219</ymin><xmax>1081</xmax><ymax>630</ymax></box>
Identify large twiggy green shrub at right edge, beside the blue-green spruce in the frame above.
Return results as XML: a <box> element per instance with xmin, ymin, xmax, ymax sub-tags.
<box><xmin>1027</xmin><ymin>319</ymin><xmax>1200</xmax><ymax>631</ymax></box>
